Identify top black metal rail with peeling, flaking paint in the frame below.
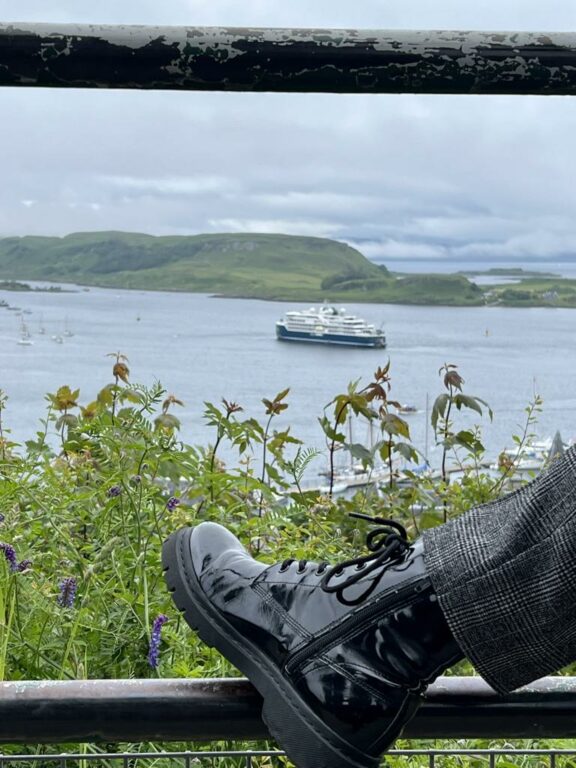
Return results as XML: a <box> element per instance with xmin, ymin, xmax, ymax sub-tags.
<box><xmin>0</xmin><ymin>23</ymin><xmax>576</xmax><ymax>95</ymax></box>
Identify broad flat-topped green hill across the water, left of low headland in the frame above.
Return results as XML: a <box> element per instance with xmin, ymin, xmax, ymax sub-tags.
<box><xmin>0</xmin><ymin>232</ymin><xmax>392</xmax><ymax>298</ymax></box>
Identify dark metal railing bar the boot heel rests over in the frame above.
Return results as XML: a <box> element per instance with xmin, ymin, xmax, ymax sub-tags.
<box><xmin>0</xmin><ymin>677</ymin><xmax>576</xmax><ymax>744</ymax></box>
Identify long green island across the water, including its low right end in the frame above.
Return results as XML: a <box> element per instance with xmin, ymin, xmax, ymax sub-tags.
<box><xmin>0</xmin><ymin>232</ymin><xmax>576</xmax><ymax>307</ymax></box>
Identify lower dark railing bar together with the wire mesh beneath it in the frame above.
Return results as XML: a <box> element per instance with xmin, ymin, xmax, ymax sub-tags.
<box><xmin>0</xmin><ymin>677</ymin><xmax>576</xmax><ymax>768</ymax></box>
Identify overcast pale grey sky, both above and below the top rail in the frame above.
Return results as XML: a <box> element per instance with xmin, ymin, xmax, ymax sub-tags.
<box><xmin>0</xmin><ymin>0</ymin><xmax>576</xmax><ymax>267</ymax></box>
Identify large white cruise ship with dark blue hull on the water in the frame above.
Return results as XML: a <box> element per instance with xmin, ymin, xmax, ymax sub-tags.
<box><xmin>276</xmin><ymin>305</ymin><xmax>386</xmax><ymax>349</ymax></box>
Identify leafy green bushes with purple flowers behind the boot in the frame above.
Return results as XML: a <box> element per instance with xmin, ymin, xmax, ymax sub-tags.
<box><xmin>0</xmin><ymin>352</ymin><xmax>568</xmax><ymax>760</ymax></box>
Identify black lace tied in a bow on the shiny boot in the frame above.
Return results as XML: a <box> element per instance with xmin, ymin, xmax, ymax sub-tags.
<box><xmin>280</xmin><ymin>512</ymin><xmax>410</xmax><ymax>605</ymax></box>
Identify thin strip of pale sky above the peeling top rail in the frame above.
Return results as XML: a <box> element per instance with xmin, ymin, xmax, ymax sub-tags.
<box><xmin>2</xmin><ymin>0</ymin><xmax>576</xmax><ymax>30</ymax></box>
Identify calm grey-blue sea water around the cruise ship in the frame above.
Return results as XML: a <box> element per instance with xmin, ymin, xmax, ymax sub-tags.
<box><xmin>0</xmin><ymin>287</ymin><xmax>576</xmax><ymax>464</ymax></box>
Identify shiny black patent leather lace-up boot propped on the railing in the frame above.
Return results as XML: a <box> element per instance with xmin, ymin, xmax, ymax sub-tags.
<box><xmin>163</xmin><ymin>519</ymin><xmax>462</xmax><ymax>768</ymax></box>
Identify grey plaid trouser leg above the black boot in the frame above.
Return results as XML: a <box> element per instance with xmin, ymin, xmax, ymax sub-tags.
<box><xmin>424</xmin><ymin>440</ymin><xmax>576</xmax><ymax>693</ymax></box>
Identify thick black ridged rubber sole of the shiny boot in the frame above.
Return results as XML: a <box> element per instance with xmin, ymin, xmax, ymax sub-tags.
<box><xmin>162</xmin><ymin>528</ymin><xmax>380</xmax><ymax>768</ymax></box>
